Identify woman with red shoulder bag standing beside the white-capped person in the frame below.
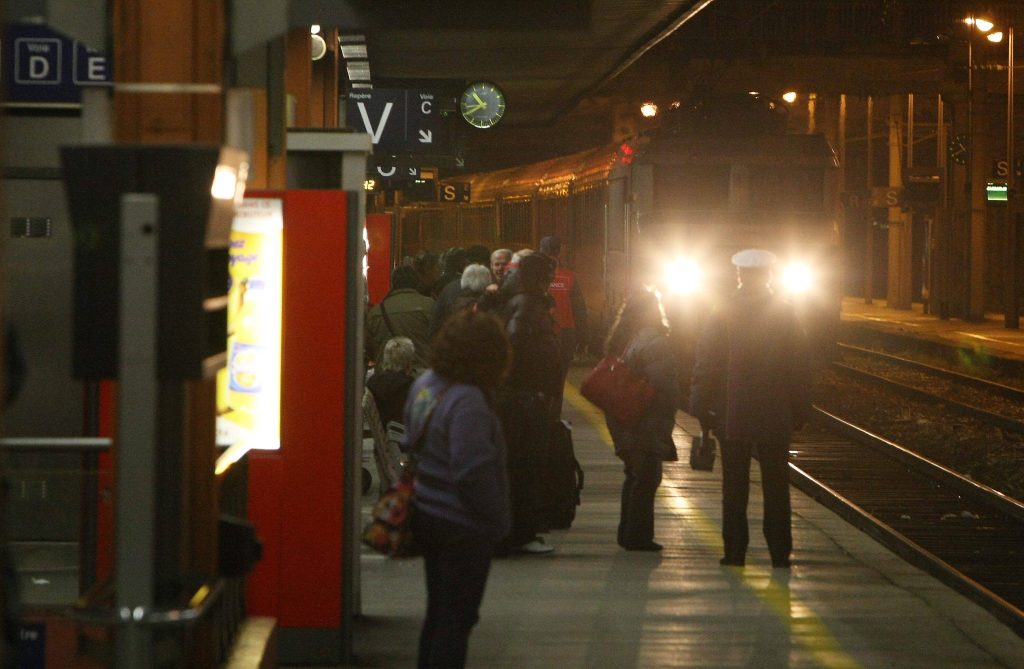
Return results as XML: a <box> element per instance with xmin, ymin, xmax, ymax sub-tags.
<box><xmin>605</xmin><ymin>290</ymin><xmax>680</xmax><ymax>551</ymax></box>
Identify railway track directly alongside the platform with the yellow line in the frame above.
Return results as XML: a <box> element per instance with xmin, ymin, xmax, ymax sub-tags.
<box><xmin>791</xmin><ymin>410</ymin><xmax>1024</xmax><ymax>636</ymax></box>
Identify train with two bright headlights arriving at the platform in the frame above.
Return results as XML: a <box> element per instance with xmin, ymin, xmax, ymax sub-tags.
<box><xmin>393</xmin><ymin>96</ymin><xmax>842</xmax><ymax>356</ymax></box>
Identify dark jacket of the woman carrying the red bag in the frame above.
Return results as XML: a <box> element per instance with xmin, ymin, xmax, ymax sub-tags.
<box><xmin>605</xmin><ymin>328</ymin><xmax>680</xmax><ymax>460</ymax></box>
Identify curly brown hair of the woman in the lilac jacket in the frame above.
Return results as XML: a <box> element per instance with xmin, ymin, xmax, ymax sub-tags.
<box><xmin>428</xmin><ymin>309</ymin><xmax>512</xmax><ymax>390</ymax></box>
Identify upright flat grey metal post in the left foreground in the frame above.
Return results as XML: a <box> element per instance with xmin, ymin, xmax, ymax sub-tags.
<box><xmin>115</xmin><ymin>194</ymin><xmax>159</xmax><ymax>669</ymax></box>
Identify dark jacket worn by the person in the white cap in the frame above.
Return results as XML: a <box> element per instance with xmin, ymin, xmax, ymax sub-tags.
<box><xmin>690</xmin><ymin>287</ymin><xmax>811</xmax><ymax>443</ymax></box>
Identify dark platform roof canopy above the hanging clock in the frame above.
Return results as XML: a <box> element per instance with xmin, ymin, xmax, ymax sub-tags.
<box><xmin>289</xmin><ymin>0</ymin><xmax>714</xmax><ymax>125</ymax></box>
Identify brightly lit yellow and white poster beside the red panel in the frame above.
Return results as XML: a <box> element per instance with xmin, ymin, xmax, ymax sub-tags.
<box><xmin>217</xmin><ymin>198</ymin><xmax>284</xmax><ymax>461</ymax></box>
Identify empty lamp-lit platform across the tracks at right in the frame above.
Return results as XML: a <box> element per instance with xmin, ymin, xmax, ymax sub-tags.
<box><xmin>840</xmin><ymin>297</ymin><xmax>1024</xmax><ymax>362</ymax></box>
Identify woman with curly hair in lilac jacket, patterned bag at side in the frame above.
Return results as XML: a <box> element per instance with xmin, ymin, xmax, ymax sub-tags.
<box><xmin>406</xmin><ymin>310</ymin><xmax>512</xmax><ymax>668</ymax></box>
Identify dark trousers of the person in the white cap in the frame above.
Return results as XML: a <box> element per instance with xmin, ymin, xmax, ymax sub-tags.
<box><xmin>722</xmin><ymin>441</ymin><xmax>793</xmax><ymax>562</ymax></box>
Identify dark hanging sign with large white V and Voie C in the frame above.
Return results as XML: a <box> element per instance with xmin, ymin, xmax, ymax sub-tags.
<box><xmin>345</xmin><ymin>88</ymin><xmax>441</xmax><ymax>154</ymax></box>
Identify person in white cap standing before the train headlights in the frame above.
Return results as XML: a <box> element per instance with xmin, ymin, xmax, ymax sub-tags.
<box><xmin>690</xmin><ymin>249</ymin><xmax>811</xmax><ymax>569</ymax></box>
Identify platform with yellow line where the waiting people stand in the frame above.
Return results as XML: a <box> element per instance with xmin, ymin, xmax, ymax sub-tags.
<box><xmin>325</xmin><ymin>367</ymin><xmax>1024</xmax><ymax>669</ymax></box>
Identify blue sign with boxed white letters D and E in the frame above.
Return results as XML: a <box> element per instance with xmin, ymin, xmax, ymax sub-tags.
<box><xmin>0</xmin><ymin>24</ymin><xmax>114</xmax><ymax>106</ymax></box>
